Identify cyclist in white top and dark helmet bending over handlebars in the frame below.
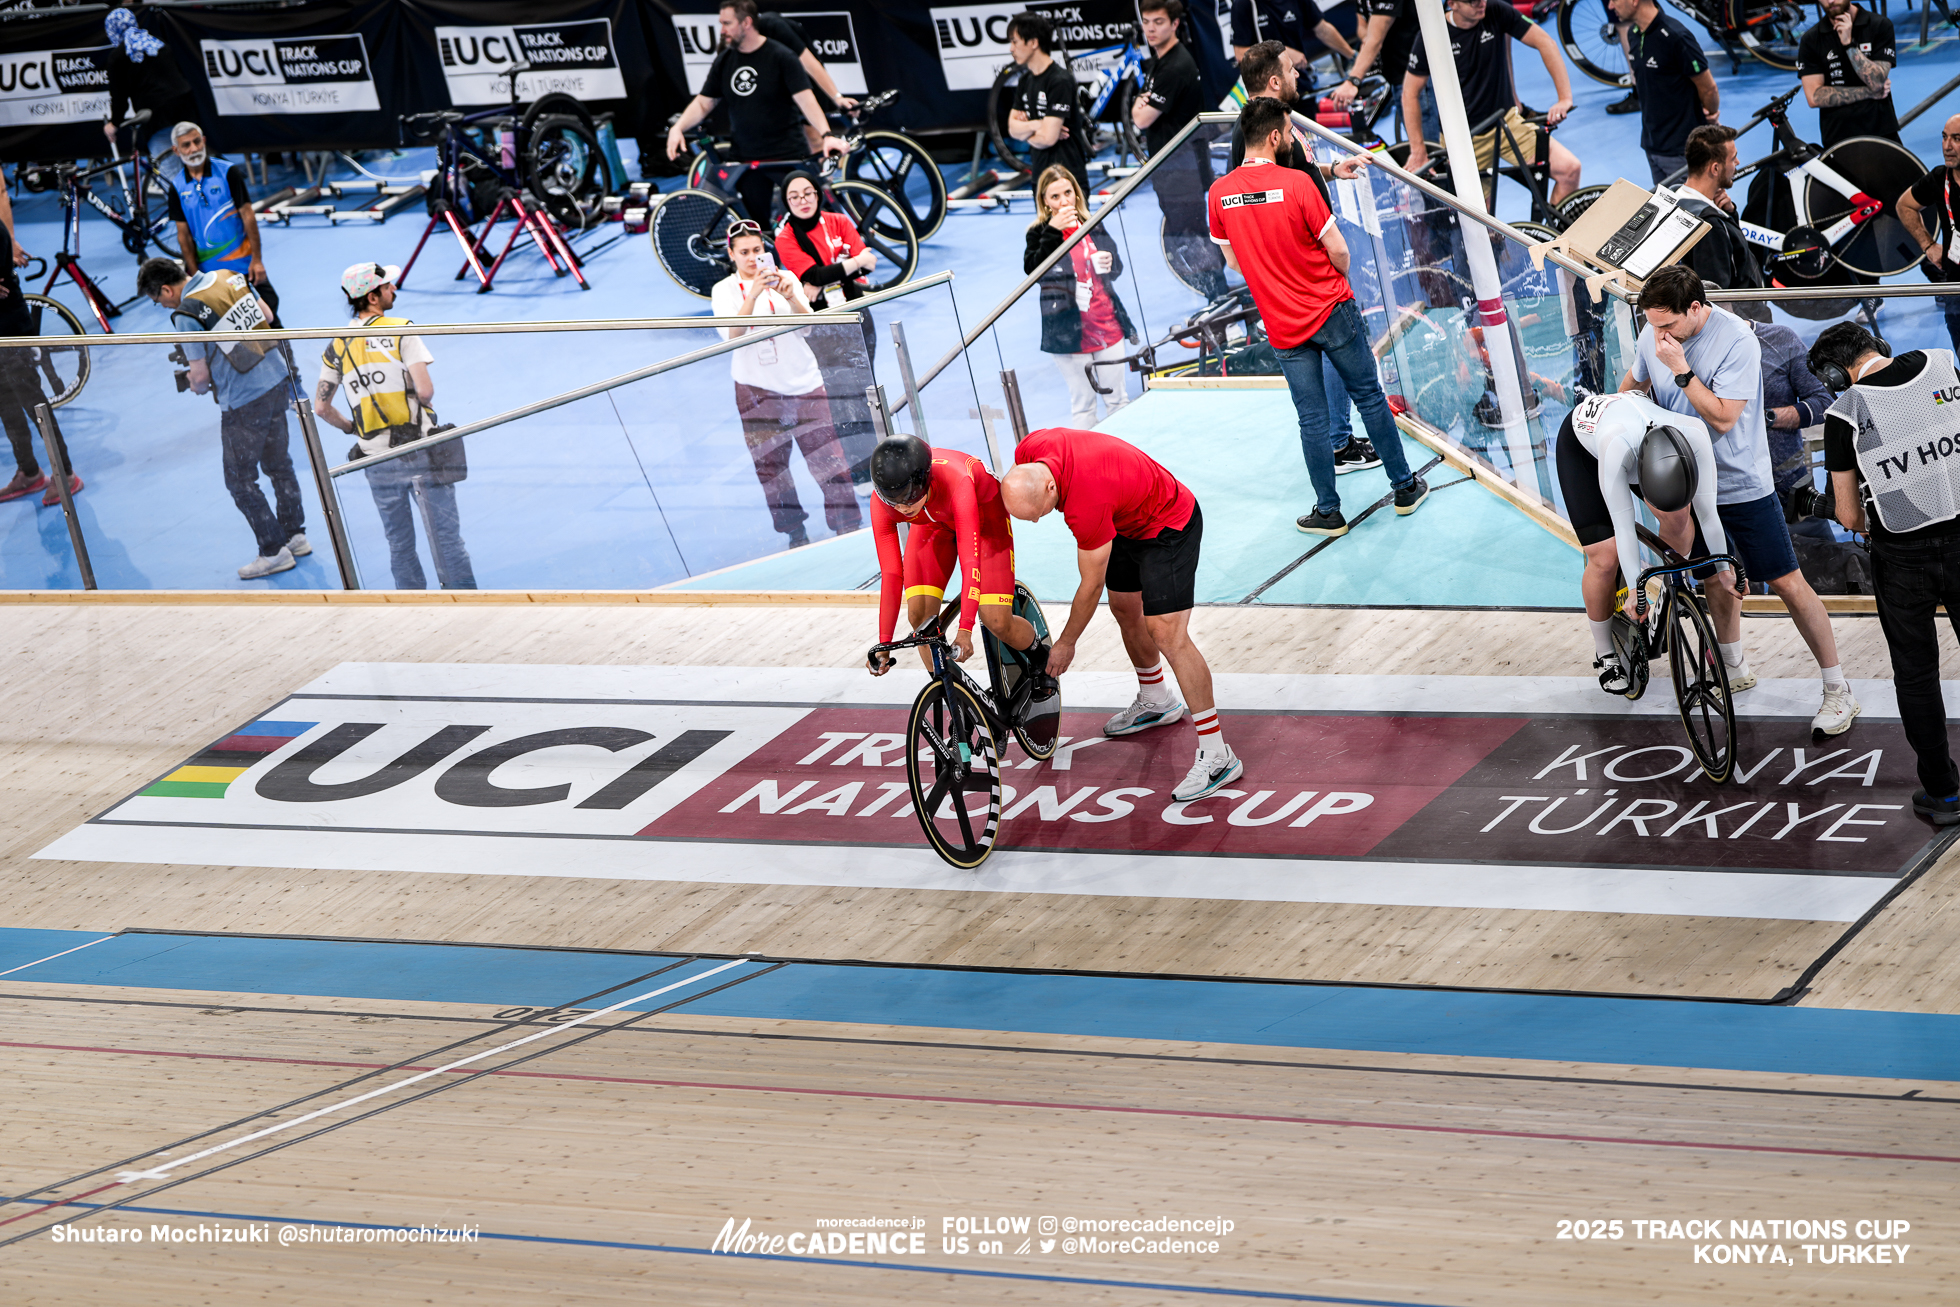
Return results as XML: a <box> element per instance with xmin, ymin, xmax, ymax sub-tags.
<box><xmin>1558</xmin><ymin>390</ymin><xmax>1735</xmax><ymax>694</ymax></box>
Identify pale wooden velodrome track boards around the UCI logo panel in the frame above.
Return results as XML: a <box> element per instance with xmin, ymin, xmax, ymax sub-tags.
<box><xmin>0</xmin><ymin>602</ymin><xmax>1960</xmax><ymax>1305</ymax></box>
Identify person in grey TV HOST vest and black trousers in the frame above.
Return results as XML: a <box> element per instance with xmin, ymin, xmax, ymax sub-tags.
<box><xmin>1809</xmin><ymin>321</ymin><xmax>1960</xmax><ymax>827</ymax></box>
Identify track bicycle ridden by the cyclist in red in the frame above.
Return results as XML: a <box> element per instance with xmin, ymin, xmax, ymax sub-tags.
<box><xmin>866</xmin><ymin>582</ymin><xmax>1062</xmax><ymax>872</ymax></box>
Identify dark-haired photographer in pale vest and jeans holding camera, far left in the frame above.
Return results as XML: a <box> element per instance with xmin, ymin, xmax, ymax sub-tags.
<box><xmin>135</xmin><ymin>259</ymin><xmax>314</xmax><ymax>580</ymax></box>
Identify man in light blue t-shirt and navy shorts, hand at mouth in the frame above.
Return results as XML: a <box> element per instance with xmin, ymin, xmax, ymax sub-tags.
<box><xmin>1619</xmin><ymin>263</ymin><xmax>1860</xmax><ymax>735</ymax></box>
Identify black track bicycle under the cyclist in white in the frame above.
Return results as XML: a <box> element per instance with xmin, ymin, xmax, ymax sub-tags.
<box><xmin>1613</xmin><ymin>525</ymin><xmax>1748</xmax><ymax>786</ymax></box>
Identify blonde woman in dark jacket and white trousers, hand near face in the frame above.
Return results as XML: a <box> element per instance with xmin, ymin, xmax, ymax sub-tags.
<box><xmin>1021</xmin><ymin>165</ymin><xmax>1137</xmax><ymax>427</ymax></box>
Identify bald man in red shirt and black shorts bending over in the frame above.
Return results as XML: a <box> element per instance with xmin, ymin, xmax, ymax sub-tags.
<box><xmin>1000</xmin><ymin>427</ymin><xmax>1245</xmax><ymax>801</ymax></box>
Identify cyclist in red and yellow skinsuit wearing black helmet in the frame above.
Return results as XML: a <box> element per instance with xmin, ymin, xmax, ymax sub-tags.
<box><xmin>870</xmin><ymin>435</ymin><xmax>1041</xmax><ymax>676</ymax></box>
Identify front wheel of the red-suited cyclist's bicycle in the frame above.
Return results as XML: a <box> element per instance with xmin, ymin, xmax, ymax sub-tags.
<box><xmin>906</xmin><ymin>680</ymin><xmax>1000</xmax><ymax>870</ymax></box>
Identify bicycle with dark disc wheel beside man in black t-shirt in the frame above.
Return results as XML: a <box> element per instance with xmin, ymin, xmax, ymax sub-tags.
<box><xmin>649</xmin><ymin>135</ymin><xmax>919</xmax><ymax>300</ymax></box>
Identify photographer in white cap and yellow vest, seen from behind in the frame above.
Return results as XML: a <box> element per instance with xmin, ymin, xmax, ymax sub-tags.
<box><xmin>314</xmin><ymin>263</ymin><xmax>476</xmax><ymax>590</ymax></box>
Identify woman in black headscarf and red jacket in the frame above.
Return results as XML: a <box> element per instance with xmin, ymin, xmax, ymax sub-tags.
<box><xmin>776</xmin><ymin>169</ymin><xmax>878</xmax><ymax>485</ymax></box>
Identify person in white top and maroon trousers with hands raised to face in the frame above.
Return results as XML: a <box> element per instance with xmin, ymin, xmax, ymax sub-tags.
<box><xmin>711</xmin><ymin>221</ymin><xmax>864</xmax><ymax>549</ymax></box>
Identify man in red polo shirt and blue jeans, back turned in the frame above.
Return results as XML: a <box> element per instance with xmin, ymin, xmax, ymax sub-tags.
<box><xmin>1209</xmin><ymin>96</ymin><xmax>1429</xmax><ymax>535</ymax></box>
